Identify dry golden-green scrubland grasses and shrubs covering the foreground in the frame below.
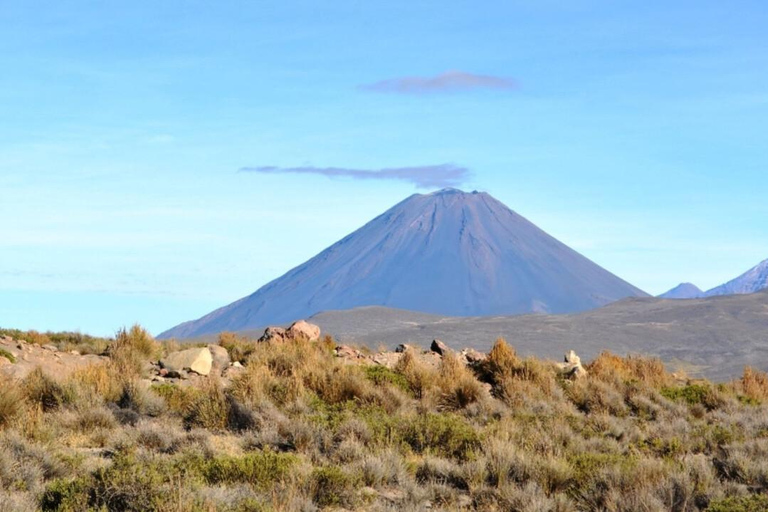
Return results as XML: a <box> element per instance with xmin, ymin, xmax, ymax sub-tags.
<box><xmin>0</xmin><ymin>327</ymin><xmax>768</xmax><ymax>512</ymax></box>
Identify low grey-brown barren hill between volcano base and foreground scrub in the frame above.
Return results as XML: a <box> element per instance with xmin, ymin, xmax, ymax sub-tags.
<box><xmin>304</xmin><ymin>292</ymin><xmax>768</xmax><ymax>380</ymax></box>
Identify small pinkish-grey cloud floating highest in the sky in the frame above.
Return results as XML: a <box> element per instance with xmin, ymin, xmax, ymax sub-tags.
<box><xmin>360</xmin><ymin>71</ymin><xmax>518</xmax><ymax>94</ymax></box>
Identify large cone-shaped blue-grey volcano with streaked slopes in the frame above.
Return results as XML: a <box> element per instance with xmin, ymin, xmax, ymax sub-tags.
<box><xmin>160</xmin><ymin>189</ymin><xmax>646</xmax><ymax>338</ymax></box>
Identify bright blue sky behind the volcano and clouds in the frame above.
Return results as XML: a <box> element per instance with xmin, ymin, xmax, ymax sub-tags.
<box><xmin>0</xmin><ymin>0</ymin><xmax>768</xmax><ymax>334</ymax></box>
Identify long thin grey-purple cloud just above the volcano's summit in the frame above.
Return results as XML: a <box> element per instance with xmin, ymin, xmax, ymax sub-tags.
<box><xmin>240</xmin><ymin>164</ymin><xmax>471</xmax><ymax>188</ymax></box>
